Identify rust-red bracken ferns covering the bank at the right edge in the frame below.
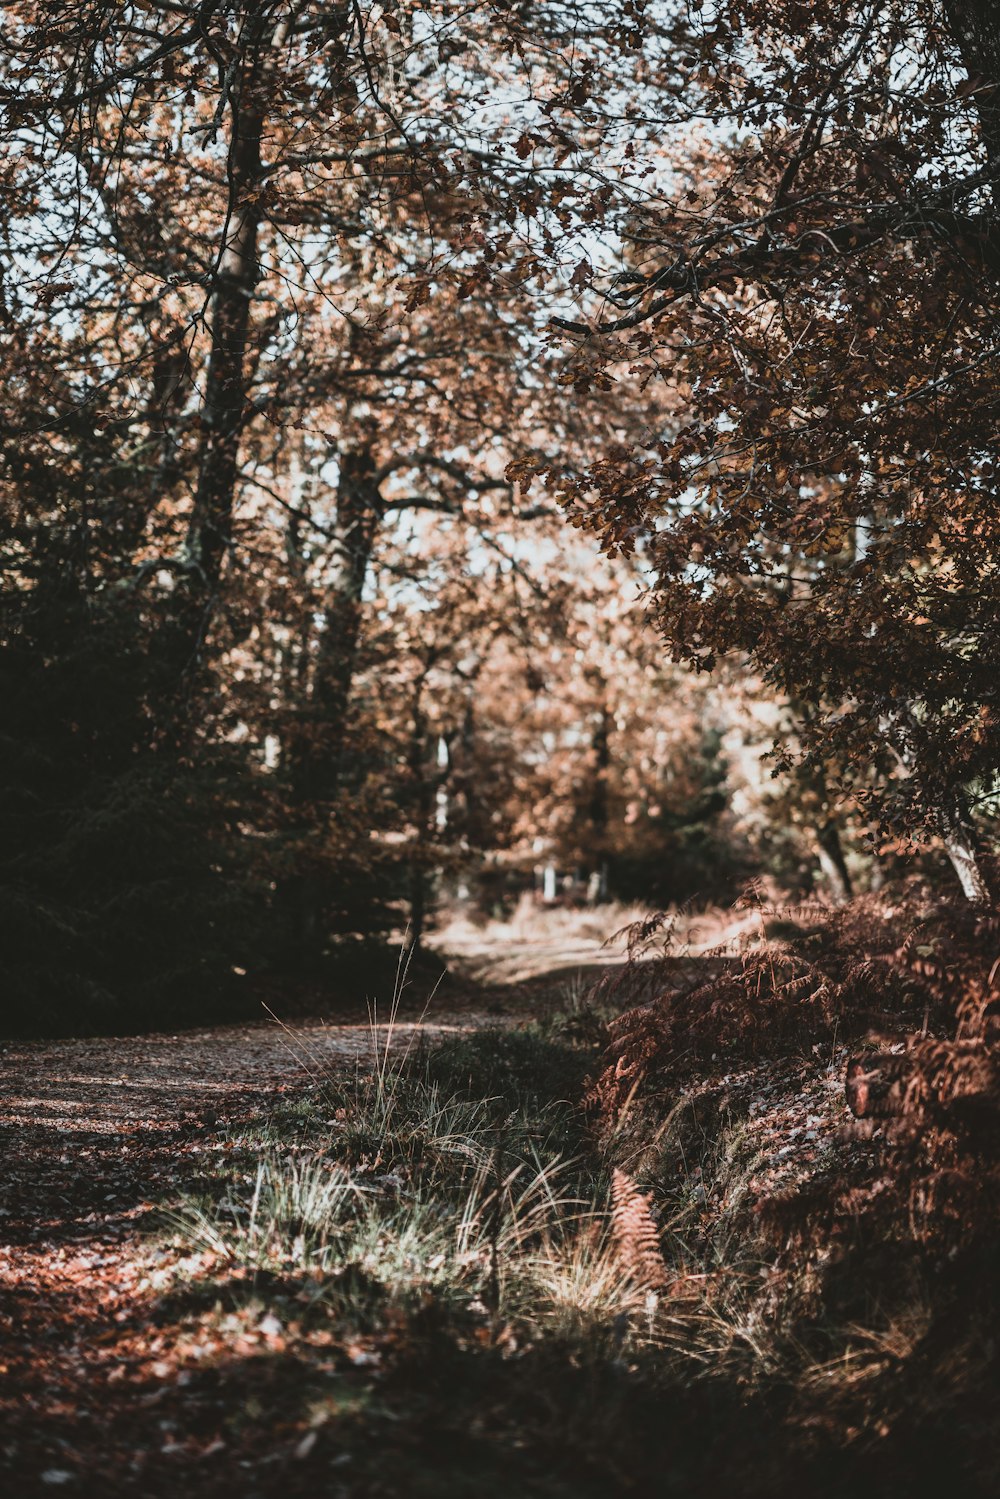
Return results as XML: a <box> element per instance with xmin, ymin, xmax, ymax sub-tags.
<box><xmin>592</xmin><ymin>886</ymin><xmax>1000</xmax><ymax>1283</ymax></box>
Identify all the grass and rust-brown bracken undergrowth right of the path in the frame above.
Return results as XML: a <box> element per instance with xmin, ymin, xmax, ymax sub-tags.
<box><xmin>158</xmin><ymin>896</ymin><xmax>999</xmax><ymax>1495</ymax></box>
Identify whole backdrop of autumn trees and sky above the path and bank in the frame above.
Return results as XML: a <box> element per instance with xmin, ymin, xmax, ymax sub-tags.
<box><xmin>0</xmin><ymin>0</ymin><xmax>1000</xmax><ymax>1031</ymax></box>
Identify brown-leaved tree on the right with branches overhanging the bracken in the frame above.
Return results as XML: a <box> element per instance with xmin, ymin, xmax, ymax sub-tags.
<box><xmin>536</xmin><ymin>0</ymin><xmax>1000</xmax><ymax>899</ymax></box>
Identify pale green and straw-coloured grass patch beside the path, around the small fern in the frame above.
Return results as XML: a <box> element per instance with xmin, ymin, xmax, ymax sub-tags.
<box><xmin>169</xmin><ymin>1006</ymin><xmax>773</xmax><ymax>1369</ymax></box>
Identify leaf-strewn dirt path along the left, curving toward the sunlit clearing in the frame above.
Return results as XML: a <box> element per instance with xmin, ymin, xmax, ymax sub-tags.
<box><xmin>0</xmin><ymin>935</ymin><xmax>626</xmax><ymax>1496</ymax></box>
